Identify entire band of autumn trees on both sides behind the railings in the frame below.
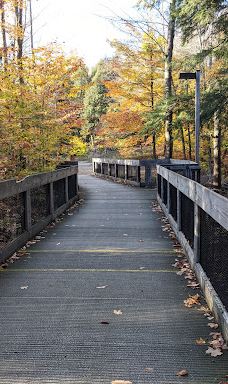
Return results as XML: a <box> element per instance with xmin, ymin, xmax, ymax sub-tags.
<box><xmin>0</xmin><ymin>0</ymin><xmax>228</xmax><ymax>187</ymax></box>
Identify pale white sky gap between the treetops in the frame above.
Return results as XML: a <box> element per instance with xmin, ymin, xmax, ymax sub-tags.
<box><xmin>32</xmin><ymin>0</ymin><xmax>136</xmax><ymax>68</ymax></box>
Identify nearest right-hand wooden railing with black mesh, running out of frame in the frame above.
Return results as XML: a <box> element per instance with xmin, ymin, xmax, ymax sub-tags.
<box><xmin>157</xmin><ymin>165</ymin><xmax>228</xmax><ymax>340</ymax></box>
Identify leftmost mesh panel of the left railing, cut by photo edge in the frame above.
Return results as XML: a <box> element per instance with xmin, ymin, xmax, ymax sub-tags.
<box><xmin>0</xmin><ymin>193</ymin><xmax>25</xmax><ymax>249</ymax></box>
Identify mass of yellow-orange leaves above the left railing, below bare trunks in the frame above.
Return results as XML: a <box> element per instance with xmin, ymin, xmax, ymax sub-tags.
<box><xmin>0</xmin><ymin>46</ymin><xmax>86</xmax><ymax>177</ymax></box>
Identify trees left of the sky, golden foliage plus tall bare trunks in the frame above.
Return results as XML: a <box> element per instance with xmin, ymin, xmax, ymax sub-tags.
<box><xmin>0</xmin><ymin>0</ymin><xmax>88</xmax><ymax>177</ymax></box>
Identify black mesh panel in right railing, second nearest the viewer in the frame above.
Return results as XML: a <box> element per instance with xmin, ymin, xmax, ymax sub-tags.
<box><xmin>181</xmin><ymin>193</ymin><xmax>194</xmax><ymax>248</ymax></box>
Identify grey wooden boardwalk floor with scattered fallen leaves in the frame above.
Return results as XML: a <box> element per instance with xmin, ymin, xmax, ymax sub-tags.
<box><xmin>0</xmin><ymin>165</ymin><xmax>228</xmax><ymax>384</ymax></box>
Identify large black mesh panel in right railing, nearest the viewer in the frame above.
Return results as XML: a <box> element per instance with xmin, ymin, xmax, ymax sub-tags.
<box><xmin>200</xmin><ymin>209</ymin><xmax>228</xmax><ymax>309</ymax></box>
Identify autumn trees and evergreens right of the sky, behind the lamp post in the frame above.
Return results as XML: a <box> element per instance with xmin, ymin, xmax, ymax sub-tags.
<box><xmin>93</xmin><ymin>0</ymin><xmax>228</xmax><ymax>187</ymax></box>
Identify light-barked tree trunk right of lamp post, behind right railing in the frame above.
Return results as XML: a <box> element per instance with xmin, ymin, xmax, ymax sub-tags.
<box><xmin>213</xmin><ymin>111</ymin><xmax>221</xmax><ymax>188</ymax></box>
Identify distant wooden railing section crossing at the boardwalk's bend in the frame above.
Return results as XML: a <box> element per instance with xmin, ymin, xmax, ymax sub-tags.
<box><xmin>92</xmin><ymin>158</ymin><xmax>200</xmax><ymax>188</ymax></box>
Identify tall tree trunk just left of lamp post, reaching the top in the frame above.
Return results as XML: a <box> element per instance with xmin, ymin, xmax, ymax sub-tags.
<box><xmin>165</xmin><ymin>0</ymin><xmax>176</xmax><ymax>158</ymax></box>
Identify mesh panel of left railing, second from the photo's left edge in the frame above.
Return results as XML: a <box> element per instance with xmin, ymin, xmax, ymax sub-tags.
<box><xmin>31</xmin><ymin>185</ymin><xmax>50</xmax><ymax>225</ymax></box>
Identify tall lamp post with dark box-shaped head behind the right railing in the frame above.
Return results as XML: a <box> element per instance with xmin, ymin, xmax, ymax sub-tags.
<box><xmin>179</xmin><ymin>70</ymin><xmax>200</xmax><ymax>164</ymax></box>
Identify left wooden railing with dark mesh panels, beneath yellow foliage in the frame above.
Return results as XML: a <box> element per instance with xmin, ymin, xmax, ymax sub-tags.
<box><xmin>0</xmin><ymin>163</ymin><xmax>78</xmax><ymax>261</ymax></box>
